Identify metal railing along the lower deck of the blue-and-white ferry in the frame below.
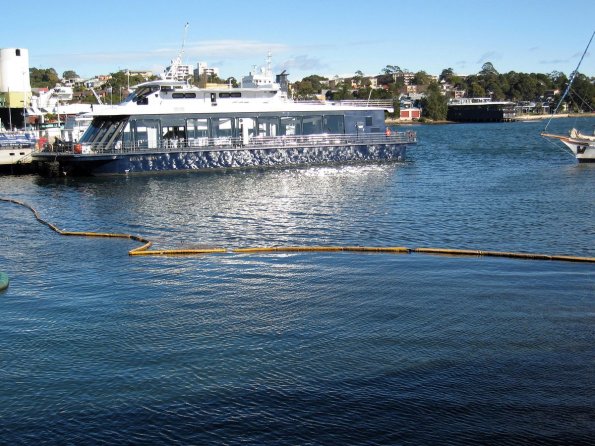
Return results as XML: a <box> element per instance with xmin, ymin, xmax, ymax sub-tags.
<box><xmin>50</xmin><ymin>131</ymin><xmax>417</xmax><ymax>155</ymax></box>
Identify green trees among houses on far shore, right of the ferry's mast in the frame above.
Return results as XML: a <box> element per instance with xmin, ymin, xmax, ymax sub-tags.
<box><xmin>292</xmin><ymin>62</ymin><xmax>595</xmax><ymax>120</ymax></box>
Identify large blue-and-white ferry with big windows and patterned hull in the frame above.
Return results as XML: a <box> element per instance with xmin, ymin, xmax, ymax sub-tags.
<box><xmin>32</xmin><ymin>67</ymin><xmax>417</xmax><ymax>176</ymax></box>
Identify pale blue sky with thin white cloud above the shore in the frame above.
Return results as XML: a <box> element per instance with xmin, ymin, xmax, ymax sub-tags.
<box><xmin>0</xmin><ymin>0</ymin><xmax>595</xmax><ymax>81</ymax></box>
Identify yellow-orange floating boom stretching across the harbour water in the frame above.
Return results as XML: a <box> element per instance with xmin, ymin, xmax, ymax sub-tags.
<box><xmin>0</xmin><ymin>197</ymin><xmax>595</xmax><ymax>263</ymax></box>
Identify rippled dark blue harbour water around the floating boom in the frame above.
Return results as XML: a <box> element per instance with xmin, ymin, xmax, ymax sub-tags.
<box><xmin>0</xmin><ymin>118</ymin><xmax>595</xmax><ymax>445</ymax></box>
